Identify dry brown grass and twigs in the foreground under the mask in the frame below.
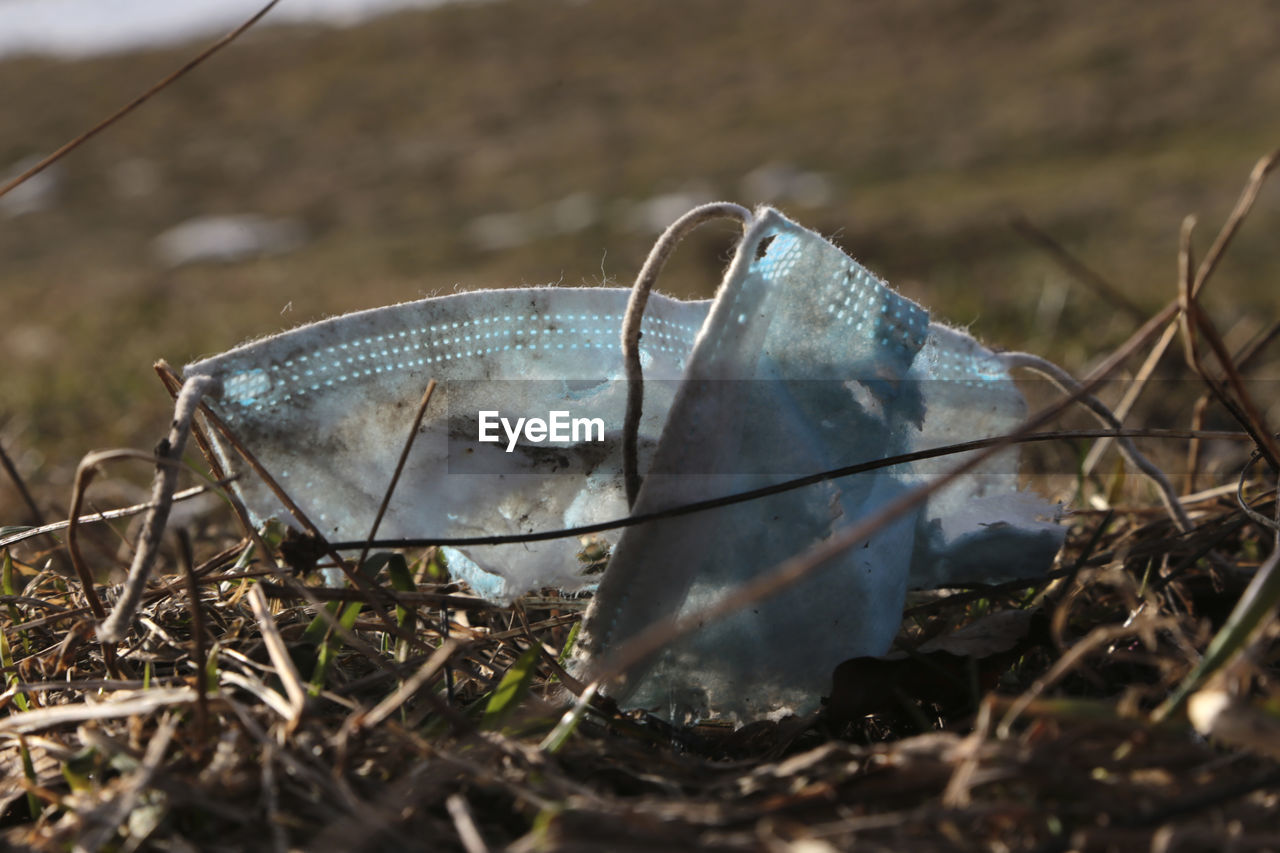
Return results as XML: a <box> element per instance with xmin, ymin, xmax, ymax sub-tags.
<box><xmin>0</xmin><ymin>3</ymin><xmax>1280</xmax><ymax>853</ymax></box>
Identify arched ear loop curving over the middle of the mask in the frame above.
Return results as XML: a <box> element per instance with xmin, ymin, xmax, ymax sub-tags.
<box><xmin>622</xmin><ymin>201</ymin><xmax>751</xmax><ymax>508</ymax></box>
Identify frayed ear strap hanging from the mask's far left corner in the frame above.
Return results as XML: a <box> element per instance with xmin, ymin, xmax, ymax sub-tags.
<box><xmin>97</xmin><ymin>377</ymin><xmax>219</xmax><ymax>643</ymax></box>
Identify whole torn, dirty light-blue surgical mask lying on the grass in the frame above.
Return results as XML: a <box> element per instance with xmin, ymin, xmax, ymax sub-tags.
<box><xmin>152</xmin><ymin>209</ymin><xmax>1062</xmax><ymax>721</ymax></box>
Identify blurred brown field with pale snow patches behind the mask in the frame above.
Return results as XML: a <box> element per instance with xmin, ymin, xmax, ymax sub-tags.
<box><xmin>0</xmin><ymin>0</ymin><xmax>1280</xmax><ymax>519</ymax></box>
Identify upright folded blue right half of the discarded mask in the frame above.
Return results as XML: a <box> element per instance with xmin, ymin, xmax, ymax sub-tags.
<box><xmin>580</xmin><ymin>211</ymin><xmax>1062</xmax><ymax>721</ymax></box>
